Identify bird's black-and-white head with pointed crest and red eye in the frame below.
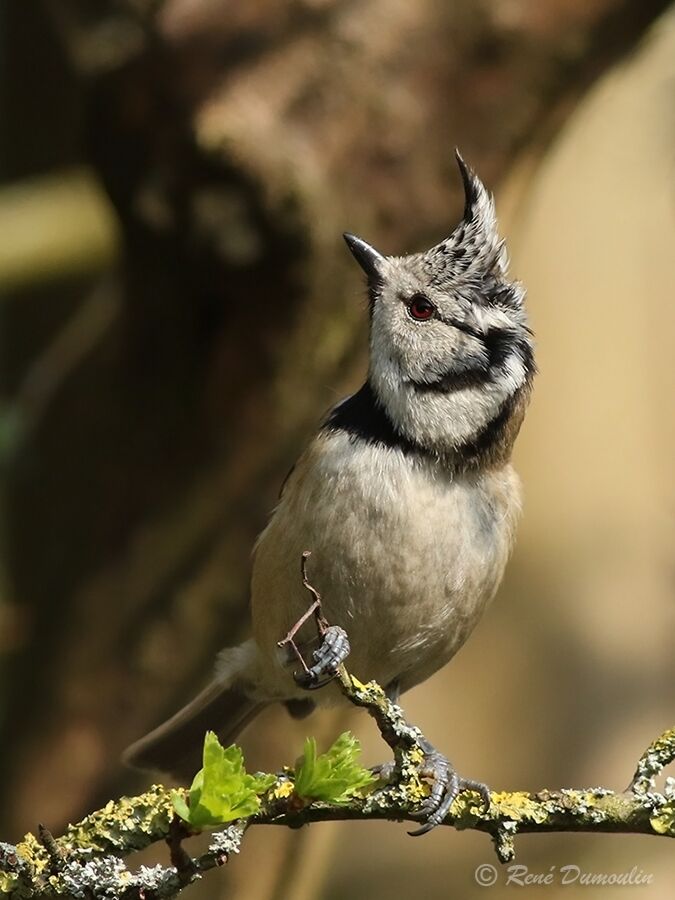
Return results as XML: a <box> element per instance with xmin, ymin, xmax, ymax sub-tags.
<box><xmin>345</xmin><ymin>153</ymin><xmax>534</xmax><ymax>464</ymax></box>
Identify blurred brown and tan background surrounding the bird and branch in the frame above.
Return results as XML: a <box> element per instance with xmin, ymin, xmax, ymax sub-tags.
<box><xmin>0</xmin><ymin>0</ymin><xmax>675</xmax><ymax>900</ymax></box>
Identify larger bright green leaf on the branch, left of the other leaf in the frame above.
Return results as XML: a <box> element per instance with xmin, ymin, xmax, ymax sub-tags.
<box><xmin>173</xmin><ymin>731</ymin><xmax>276</xmax><ymax>829</ymax></box>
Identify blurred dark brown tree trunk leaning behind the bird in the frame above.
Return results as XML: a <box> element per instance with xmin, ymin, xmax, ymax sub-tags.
<box><xmin>2</xmin><ymin>0</ymin><xmax>666</xmax><ymax>892</ymax></box>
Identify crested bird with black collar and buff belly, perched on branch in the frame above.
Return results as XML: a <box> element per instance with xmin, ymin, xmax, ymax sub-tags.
<box><xmin>124</xmin><ymin>151</ymin><xmax>536</xmax><ymax>831</ymax></box>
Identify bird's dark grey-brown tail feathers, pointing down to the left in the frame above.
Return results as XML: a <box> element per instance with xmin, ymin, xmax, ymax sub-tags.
<box><xmin>122</xmin><ymin>678</ymin><xmax>267</xmax><ymax>783</ymax></box>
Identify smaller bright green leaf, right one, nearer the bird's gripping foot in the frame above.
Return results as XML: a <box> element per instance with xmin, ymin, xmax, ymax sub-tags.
<box><xmin>295</xmin><ymin>731</ymin><xmax>377</xmax><ymax>803</ymax></box>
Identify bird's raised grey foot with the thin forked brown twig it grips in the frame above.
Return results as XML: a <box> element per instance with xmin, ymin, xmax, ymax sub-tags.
<box><xmin>279</xmin><ymin>550</ymin><xmax>351</xmax><ymax>691</ymax></box>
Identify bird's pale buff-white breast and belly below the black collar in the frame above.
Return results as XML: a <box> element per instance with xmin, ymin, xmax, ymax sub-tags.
<box><xmin>252</xmin><ymin>432</ymin><xmax>519</xmax><ymax>689</ymax></box>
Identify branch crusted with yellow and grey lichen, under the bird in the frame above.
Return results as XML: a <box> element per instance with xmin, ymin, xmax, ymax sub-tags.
<box><xmin>0</xmin><ymin>668</ymin><xmax>675</xmax><ymax>900</ymax></box>
